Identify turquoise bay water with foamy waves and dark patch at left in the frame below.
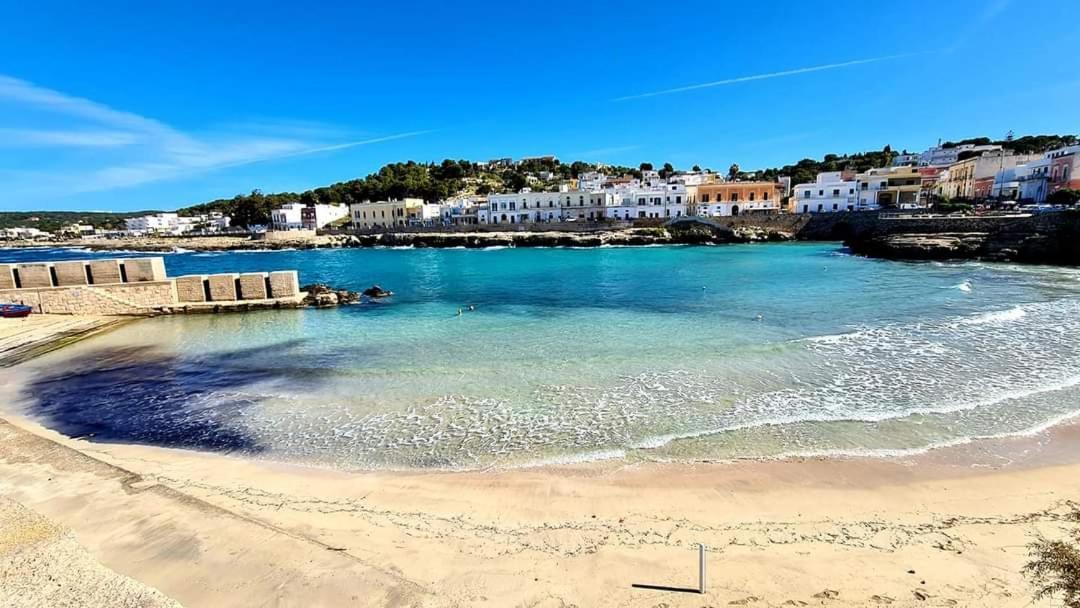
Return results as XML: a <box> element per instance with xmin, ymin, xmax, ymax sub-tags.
<box><xmin>0</xmin><ymin>244</ymin><xmax>1080</xmax><ymax>469</ymax></box>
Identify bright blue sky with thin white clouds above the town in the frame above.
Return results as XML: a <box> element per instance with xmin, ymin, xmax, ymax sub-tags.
<box><xmin>0</xmin><ymin>0</ymin><xmax>1080</xmax><ymax>211</ymax></box>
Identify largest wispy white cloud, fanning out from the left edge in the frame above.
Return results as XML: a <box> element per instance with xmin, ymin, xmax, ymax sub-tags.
<box><xmin>0</xmin><ymin>75</ymin><xmax>429</xmax><ymax>197</ymax></box>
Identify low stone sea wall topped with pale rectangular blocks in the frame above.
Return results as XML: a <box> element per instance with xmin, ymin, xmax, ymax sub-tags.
<box><xmin>0</xmin><ymin>257</ymin><xmax>303</xmax><ymax>315</ymax></box>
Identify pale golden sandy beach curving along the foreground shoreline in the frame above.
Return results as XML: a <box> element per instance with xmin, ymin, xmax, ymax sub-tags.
<box><xmin>0</xmin><ymin>412</ymin><xmax>1080</xmax><ymax>608</ymax></box>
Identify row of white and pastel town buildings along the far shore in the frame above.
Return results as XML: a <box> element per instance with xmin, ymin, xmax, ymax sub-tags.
<box><xmin>6</xmin><ymin>141</ymin><xmax>1080</xmax><ymax>241</ymax></box>
